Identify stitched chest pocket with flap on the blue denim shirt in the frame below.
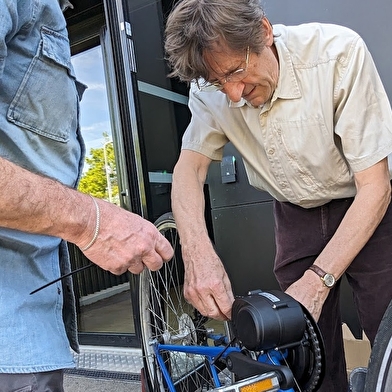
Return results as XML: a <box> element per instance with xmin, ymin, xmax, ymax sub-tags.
<box><xmin>7</xmin><ymin>27</ymin><xmax>79</xmax><ymax>142</ymax></box>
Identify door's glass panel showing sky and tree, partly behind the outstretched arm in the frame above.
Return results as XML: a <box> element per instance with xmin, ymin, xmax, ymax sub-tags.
<box><xmin>70</xmin><ymin>46</ymin><xmax>135</xmax><ymax>334</ymax></box>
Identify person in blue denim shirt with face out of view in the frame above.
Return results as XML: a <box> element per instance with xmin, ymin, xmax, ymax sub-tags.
<box><xmin>0</xmin><ymin>0</ymin><xmax>172</xmax><ymax>392</ymax></box>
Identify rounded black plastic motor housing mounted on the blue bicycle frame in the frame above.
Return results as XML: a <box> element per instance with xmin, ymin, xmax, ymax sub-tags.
<box><xmin>232</xmin><ymin>290</ymin><xmax>306</xmax><ymax>351</ymax></box>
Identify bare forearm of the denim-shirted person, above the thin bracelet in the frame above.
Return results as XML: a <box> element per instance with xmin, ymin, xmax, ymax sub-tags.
<box><xmin>0</xmin><ymin>158</ymin><xmax>91</xmax><ymax>242</ymax></box>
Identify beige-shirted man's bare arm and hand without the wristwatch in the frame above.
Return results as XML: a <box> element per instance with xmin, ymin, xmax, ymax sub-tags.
<box><xmin>172</xmin><ymin>150</ymin><xmax>234</xmax><ymax>320</ymax></box>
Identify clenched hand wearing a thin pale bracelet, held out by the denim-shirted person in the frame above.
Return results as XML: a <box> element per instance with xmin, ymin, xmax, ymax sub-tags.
<box><xmin>77</xmin><ymin>199</ymin><xmax>173</xmax><ymax>275</ymax></box>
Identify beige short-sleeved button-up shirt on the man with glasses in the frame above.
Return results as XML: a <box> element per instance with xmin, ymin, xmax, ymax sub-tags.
<box><xmin>182</xmin><ymin>23</ymin><xmax>392</xmax><ymax>208</ymax></box>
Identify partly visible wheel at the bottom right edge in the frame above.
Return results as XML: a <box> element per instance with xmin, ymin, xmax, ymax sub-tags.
<box><xmin>364</xmin><ymin>301</ymin><xmax>392</xmax><ymax>392</ymax></box>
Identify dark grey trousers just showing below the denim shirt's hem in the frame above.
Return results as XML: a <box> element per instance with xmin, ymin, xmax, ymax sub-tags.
<box><xmin>0</xmin><ymin>370</ymin><xmax>64</xmax><ymax>392</ymax></box>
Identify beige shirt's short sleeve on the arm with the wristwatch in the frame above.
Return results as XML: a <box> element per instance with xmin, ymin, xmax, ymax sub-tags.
<box><xmin>335</xmin><ymin>38</ymin><xmax>392</xmax><ymax>172</ymax></box>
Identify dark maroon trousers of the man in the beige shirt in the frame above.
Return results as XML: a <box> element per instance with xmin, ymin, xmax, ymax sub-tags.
<box><xmin>274</xmin><ymin>199</ymin><xmax>392</xmax><ymax>392</ymax></box>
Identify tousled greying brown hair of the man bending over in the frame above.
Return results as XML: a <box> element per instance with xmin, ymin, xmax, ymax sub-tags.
<box><xmin>165</xmin><ymin>0</ymin><xmax>265</xmax><ymax>82</ymax></box>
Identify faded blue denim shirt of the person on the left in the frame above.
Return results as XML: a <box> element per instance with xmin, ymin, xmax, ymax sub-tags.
<box><xmin>0</xmin><ymin>0</ymin><xmax>85</xmax><ymax>373</ymax></box>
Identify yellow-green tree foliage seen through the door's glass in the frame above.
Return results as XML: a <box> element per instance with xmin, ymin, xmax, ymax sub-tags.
<box><xmin>78</xmin><ymin>141</ymin><xmax>119</xmax><ymax>204</ymax></box>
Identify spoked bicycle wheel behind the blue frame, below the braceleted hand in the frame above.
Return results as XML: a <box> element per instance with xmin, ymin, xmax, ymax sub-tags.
<box><xmin>139</xmin><ymin>213</ymin><xmax>231</xmax><ymax>392</ymax></box>
